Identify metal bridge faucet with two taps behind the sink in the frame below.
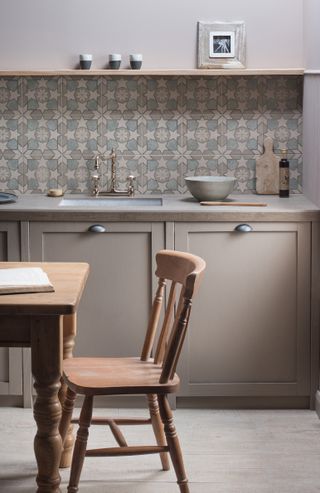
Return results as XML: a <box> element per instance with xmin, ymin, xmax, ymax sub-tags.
<box><xmin>92</xmin><ymin>149</ymin><xmax>135</xmax><ymax>197</ymax></box>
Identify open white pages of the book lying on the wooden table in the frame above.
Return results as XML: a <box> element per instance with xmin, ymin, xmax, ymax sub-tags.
<box><xmin>0</xmin><ymin>267</ymin><xmax>52</xmax><ymax>289</ymax></box>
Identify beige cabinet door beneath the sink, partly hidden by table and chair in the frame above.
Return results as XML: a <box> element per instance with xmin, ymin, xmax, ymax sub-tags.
<box><xmin>30</xmin><ymin>222</ymin><xmax>164</xmax><ymax>356</ymax></box>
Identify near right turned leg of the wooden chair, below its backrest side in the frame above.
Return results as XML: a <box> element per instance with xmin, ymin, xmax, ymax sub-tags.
<box><xmin>158</xmin><ymin>395</ymin><xmax>190</xmax><ymax>493</ymax></box>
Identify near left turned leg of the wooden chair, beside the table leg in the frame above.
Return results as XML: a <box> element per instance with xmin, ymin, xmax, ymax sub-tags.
<box><xmin>68</xmin><ymin>396</ymin><xmax>93</xmax><ymax>493</ymax></box>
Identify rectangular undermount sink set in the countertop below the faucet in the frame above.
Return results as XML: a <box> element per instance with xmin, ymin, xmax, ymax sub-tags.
<box><xmin>59</xmin><ymin>197</ymin><xmax>162</xmax><ymax>208</ymax></box>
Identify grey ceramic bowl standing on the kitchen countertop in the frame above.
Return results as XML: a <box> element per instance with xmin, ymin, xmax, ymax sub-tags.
<box><xmin>185</xmin><ymin>176</ymin><xmax>236</xmax><ymax>201</ymax></box>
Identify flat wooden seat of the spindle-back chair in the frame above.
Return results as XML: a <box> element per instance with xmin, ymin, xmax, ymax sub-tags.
<box><xmin>63</xmin><ymin>358</ymin><xmax>179</xmax><ymax>395</ymax></box>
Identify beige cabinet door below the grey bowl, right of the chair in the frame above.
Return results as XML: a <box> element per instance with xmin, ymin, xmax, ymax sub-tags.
<box><xmin>175</xmin><ymin>223</ymin><xmax>311</xmax><ymax>396</ymax></box>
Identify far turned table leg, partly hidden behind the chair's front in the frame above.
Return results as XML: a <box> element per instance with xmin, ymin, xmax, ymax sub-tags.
<box><xmin>59</xmin><ymin>313</ymin><xmax>77</xmax><ymax>467</ymax></box>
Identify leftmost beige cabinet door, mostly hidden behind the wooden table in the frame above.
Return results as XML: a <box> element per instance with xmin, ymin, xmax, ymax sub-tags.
<box><xmin>0</xmin><ymin>222</ymin><xmax>22</xmax><ymax>395</ymax></box>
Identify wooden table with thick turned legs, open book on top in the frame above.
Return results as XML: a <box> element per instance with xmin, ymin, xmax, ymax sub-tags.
<box><xmin>0</xmin><ymin>262</ymin><xmax>89</xmax><ymax>493</ymax></box>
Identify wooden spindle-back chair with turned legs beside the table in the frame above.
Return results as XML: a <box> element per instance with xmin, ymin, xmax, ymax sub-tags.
<box><xmin>60</xmin><ymin>250</ymin><xmax>205</xmax><ymax>493</ymax></box>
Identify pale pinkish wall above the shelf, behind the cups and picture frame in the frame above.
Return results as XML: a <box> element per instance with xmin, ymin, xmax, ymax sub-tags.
<box><xmin>0</xmin><ymin>0</ymin><xmax>304</xmax><ymax>69</ymax></box>
